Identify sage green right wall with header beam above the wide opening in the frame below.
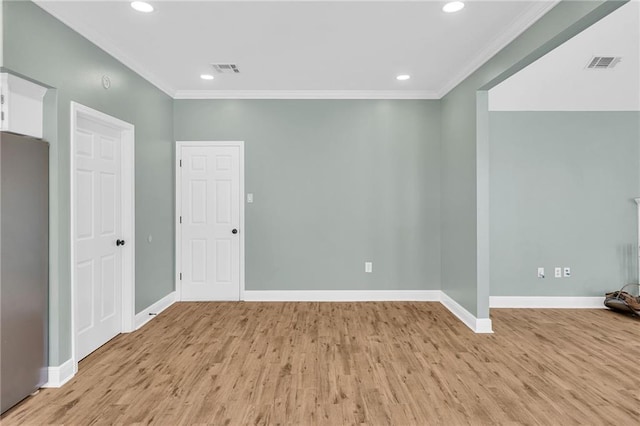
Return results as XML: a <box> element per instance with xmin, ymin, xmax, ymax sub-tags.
<box><xmin>441</xmin><ymin>0</ymin><xmax>625</xmax><ymax>318</ymax></box>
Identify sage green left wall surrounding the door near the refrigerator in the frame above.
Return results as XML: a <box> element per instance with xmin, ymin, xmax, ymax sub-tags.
<box><xmin>3</xmin><ymin>1</ymin><xmax>174</xmax><ymax>365</ymax></box>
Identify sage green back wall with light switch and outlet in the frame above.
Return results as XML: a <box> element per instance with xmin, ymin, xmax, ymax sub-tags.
<box><xmin>174</xmin><ymin>100</ymin><xmax>440</xmax><ymax>290</ymax></box>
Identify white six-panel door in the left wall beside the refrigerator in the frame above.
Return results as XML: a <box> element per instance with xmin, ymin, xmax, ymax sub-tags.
<box><xmin>72</xmin><ymin>116</ymin><xmax>126</xmax><ymax>360</ymax></box>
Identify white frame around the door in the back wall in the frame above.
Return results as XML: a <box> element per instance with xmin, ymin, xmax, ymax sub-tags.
<box><xmin>175</xmin><ymin>141</ymin><xmax>245</xmax><ymax>300</ymax></box>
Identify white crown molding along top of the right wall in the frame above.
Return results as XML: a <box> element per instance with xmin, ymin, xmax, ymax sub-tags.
<box><xmin>438</xmin><ymin>0</ymin><xmax>561</xmax><ymax>99</ymax></box>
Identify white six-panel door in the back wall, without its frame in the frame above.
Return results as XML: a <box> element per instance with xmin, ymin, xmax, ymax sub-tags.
<box><xmin>179</xmin><ymin>145</ymin><xmax>243</xmax><ymax>301</ymax></box>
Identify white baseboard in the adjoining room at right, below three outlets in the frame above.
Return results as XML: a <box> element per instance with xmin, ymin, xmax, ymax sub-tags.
<box><xmin>489</xmin><ymin>295</ymin><xmax>606</xmax><ymax>309</ymax></box>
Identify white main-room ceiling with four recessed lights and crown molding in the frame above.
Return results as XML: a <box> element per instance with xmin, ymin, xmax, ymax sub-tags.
<box><xmin>36</xmin><ymin>0</ymin><xmax>557</xmax><ymax>99</ymax></box>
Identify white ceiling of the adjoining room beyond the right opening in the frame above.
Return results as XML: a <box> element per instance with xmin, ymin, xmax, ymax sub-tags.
<box><xmin>489</xmin><ymin>0</ymin><xmax>640</xmax><ymax>111</ymax></box>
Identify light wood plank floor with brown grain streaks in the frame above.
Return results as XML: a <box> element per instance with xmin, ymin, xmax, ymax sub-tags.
<box><xmin>2</xmin><ymin>303</ymin><xmax>640</xmax><ymax>426</ymax></box>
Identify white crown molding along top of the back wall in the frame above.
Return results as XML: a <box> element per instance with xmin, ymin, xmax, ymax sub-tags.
<box><xmin>174</xmin><ymin>90</ymin><xmax>439</xmax><ymax>99</ymax></box>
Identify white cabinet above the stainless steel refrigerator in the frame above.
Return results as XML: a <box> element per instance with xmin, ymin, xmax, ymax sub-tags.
<box><xmin>0</xmin><ymin>73</ymin><xmax>47</xmax><ymax>138</ymax></box>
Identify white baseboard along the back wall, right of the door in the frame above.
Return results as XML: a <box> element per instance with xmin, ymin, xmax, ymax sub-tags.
<box><xmin>244</xmin><ymin>290</ymin><xmax>441</xmax><ymax>302</ymax></box>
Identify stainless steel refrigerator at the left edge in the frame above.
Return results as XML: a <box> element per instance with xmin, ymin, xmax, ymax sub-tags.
<box><xmin>0</xmin><ymin>132</ymin><xmax>49</xmax><ymax>412</ymax></box>
